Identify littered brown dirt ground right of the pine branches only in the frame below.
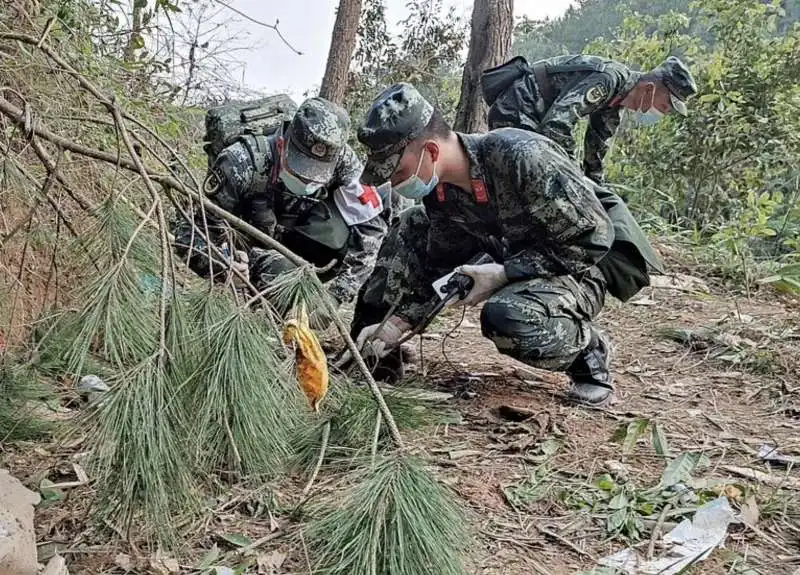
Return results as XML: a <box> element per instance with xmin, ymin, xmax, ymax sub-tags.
<box><xmin>412</xmin><ymin>268</ymin><xmax>800</xmax><ymax>574</ymax></box>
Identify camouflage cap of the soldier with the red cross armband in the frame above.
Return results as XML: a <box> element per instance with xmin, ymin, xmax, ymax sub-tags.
<box><xmin>286</xmin><ymin>98</ymin><xmax>350</xmax><ymax>183</ymax></box>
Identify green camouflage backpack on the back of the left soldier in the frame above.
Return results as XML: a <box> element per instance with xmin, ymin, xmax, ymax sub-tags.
<box><xmin>203</xmin><ymin>94</ymin><xmax>297</xmax><ymax>167</ymax></box>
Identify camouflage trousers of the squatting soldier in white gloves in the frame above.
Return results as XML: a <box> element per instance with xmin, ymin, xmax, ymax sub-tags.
<box><xmin>351</xmin><ymin>207</ymin><xmax>606</xmax><ymax>371</ymax></box>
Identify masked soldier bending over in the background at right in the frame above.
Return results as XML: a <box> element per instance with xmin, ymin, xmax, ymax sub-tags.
<box><xmin>481</xmin><ymin>55</ymin><xmax>697</xmax><ymax>183</ymax></box>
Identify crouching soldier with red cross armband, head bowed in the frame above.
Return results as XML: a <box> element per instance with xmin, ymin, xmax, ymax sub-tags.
<box><xmin>175</xmin><ymin>98</ymin><xmax>387</xmax><ymax>312</ymax></box>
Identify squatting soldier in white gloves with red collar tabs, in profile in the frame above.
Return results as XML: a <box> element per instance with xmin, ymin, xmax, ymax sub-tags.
<box><xmin>352</xmin><ymin>84</ymin><xmax>660</xmax><ymax>404</ymax></box>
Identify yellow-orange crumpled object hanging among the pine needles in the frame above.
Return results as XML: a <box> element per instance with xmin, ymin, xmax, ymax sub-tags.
<box><xmin>283</xmin><ymin>304</ymin><xmax>328</xmax><ymax>412</ymax></box>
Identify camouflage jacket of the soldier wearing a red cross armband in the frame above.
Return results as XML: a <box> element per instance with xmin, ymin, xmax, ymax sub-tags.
<box><xmin>175</xmin><ymin>136</ymin><xmax>387</xmax><ymax>303</ymax></box>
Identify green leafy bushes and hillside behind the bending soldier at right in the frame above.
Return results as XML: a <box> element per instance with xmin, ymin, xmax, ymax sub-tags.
<box><xmin>514</xmin><ymin>0</ymin><xmax>800</xmax><ymax>287</ymax></box>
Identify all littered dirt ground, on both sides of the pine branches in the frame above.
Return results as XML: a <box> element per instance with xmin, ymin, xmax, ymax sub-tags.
<box><xmin>0</xmin><ymin>262</ymin><xmax>800</xmax><ymax>575</ymax></box>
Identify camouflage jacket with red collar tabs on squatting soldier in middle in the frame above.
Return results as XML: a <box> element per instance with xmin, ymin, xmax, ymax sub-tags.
<box><xmin>396</xmin><ymin>128</ymin><xmax>614</xmax><ymax>324</ymax></box>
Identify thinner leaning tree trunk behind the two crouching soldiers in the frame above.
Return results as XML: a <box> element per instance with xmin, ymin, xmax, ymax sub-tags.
<box><xmin>319</xmin><ymin>0</ymin><xmax>361</xmax><ymax>104</ymax></box>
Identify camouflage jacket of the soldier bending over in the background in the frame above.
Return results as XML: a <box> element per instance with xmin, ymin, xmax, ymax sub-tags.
<box><xmin>489</xmin><ymin>55</ymin><xmax>641</xmax><ymax>183</ymax></box>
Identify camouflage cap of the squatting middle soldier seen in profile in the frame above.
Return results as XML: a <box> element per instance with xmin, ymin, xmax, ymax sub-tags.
<box><xmin>358</xmin><ymin>82</ymin><xmax>433</xmax><ymax>185</ymax></box>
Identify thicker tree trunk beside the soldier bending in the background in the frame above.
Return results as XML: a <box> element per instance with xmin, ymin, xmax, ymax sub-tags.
<box><xmin>454</xmin><ymin>0</ymin><xmax>514</xmax><ymax>134</ymax></box>
